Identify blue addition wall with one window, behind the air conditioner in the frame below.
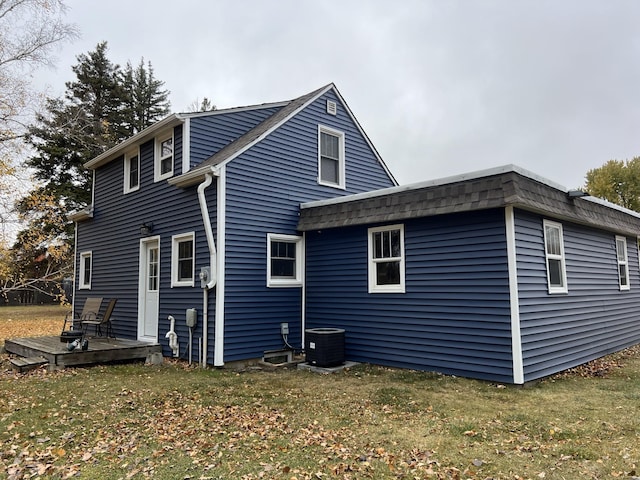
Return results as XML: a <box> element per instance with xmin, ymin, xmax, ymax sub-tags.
<box><xmin>306</xmin><ymin>209</ymin><xmax>513</xmax><ymax>382</ymax></box>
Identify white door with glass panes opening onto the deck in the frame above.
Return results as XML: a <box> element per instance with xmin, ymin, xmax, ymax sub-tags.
<box><xmin>138</xmin><ymin>238</ymin><xmax>160</xmax><ymax>342</ymax></box>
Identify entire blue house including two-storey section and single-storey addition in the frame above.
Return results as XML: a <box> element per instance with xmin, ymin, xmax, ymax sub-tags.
<box><xmin>72</xmin><ymin>84</ymin><xmax>640</xmax><ymax>384</ymax></box>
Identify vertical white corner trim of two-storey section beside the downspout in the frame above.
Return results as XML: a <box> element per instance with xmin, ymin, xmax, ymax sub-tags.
<box><xmin>214</xmin><ymin>165</ymin><xmax>227</xmax><ymax>367</ymax></box>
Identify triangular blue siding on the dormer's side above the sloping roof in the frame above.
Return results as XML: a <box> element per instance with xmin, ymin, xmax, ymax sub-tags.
<box><xmin>190</xmin><ymin>107</ymin><xmax>281</xmax><ymax>167</ymax></box>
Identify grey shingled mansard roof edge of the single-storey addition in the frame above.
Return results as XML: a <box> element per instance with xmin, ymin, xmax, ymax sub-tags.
<box><xmin>298</xmin><ymin>165</ymin><xmax>640</xmax><ymax>236</ymax></box>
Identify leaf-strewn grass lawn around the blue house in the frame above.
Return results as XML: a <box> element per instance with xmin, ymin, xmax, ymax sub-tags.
<box><xmin>0</xmin><ymin>309</ymin><xmax>640</xmax><ymax>480</ymax></box>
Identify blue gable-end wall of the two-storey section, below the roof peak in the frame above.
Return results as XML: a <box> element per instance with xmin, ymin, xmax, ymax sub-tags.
<box><xmin>224</xmin><ymin>91</ymin><xmax>394</xmax><ymax>362</ymax></box>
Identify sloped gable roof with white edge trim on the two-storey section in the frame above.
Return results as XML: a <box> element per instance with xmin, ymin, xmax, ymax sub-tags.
<box><xmin>168</xmin><ymin>83</ymin><xmax>397</xmax><ymax>187</ymax></box>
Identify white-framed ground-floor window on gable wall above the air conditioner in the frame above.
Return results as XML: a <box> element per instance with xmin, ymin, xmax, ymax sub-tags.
<box><xmin>267</xmin><ymin>233</ymin><xmax>304</xmax><ymax>287</ymax></box>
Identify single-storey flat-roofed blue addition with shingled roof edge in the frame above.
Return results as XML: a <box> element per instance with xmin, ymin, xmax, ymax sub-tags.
<box><xmin>298</xmin><ymin>165</ymin><xmax>640</xmax><ymax>384</ymax></box>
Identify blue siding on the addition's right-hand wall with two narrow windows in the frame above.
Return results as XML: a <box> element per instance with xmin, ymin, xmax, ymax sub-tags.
<box><xmin>516</xmin><ymin>210</ymin><xmax>640</xmax><ymax>381</ymax></box>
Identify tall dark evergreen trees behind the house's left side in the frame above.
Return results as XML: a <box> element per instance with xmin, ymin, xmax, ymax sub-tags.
<box><xmin>14</xmin><ymin>42</ymin><xmax>169</xmax><ymax>288</ymax></box>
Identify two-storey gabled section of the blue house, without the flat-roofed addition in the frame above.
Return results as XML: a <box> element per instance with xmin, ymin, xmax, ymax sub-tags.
<box><xmin>72</xmin><ymin>84</ymin><xmax>396</xmax><ymax>366</ymax></box>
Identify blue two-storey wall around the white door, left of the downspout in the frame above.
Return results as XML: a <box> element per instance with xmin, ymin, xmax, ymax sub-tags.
<box><xmin>75</xmin><ymin>127</ymin><xmax>216</xmax><ymax>356</ymax></box>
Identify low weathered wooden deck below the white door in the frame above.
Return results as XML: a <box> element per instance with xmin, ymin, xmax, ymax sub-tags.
<box><xmin>4</xmin><ymin>336</ymin><xmax>162</xmax><ymax>370</ymax></box>
